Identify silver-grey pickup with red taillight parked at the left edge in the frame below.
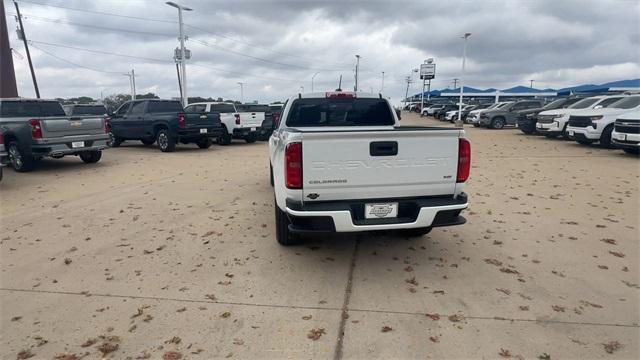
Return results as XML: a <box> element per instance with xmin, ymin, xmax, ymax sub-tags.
<box><xmin>0</xmin><ymin>98</ymin><xmax>109</xmax><ymax>172</ymax></box>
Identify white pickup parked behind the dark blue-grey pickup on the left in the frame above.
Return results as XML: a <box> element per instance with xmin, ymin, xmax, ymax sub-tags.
<box><xmin>185</xmin><ymin>102</ymin><xmax>264</xmax><ymax>145</ymax></box>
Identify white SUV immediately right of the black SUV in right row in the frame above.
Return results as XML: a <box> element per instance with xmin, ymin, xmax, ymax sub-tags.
<box><xmin>536</xmin><ymin>95</ymin><xmax>626</xmax><ymax>138</ymax></box>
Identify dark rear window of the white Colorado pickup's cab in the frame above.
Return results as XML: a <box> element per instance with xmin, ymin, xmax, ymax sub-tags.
<box><xmin>286</xmin><ymin>98</ymin><xmax>395</xmax><ymax>127</ymax></box>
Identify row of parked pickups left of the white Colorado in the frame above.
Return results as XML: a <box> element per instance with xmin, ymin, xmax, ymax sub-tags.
<box><xmin>0</xmin><ymin>98</ymin><xmax>282</xmax><ymax>179</ymax></box>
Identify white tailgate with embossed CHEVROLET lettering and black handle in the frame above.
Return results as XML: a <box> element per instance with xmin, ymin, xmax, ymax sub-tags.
<box><xmin>302</xmin><ymin>128</ymin><xmax>461</xmax><ymax>201</ymax></box>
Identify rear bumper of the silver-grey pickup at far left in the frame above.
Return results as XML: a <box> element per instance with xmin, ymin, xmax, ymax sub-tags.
<box><xmin>31</xmin><ymin>134</ymin><xmax>109</xmax><ymax>156</ymax></box>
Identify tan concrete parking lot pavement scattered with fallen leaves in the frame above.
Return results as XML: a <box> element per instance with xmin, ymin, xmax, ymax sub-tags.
<box><xmin>0</xmin><ymin>114</ymin><xmax>640</xmax><ymax>359</ymax></box>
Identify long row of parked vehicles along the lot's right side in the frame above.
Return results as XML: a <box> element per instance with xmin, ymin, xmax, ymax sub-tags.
<box><xmin>422</xmin><ymin>93</ymin><xmax>640</xmax><ymax>155</ymax></box>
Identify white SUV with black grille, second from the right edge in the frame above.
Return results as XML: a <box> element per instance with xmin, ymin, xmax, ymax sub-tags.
<box><xmin>567</xmin><ymin>95</ymin><xmax>640</xmax><ymax>148</ymax></box>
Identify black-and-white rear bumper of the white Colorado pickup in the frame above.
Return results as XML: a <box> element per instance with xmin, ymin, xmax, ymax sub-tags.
<box><xmin>285</xmin><ymin>193</ymin><xmax>468</xmax><ymax>233</ymax></box>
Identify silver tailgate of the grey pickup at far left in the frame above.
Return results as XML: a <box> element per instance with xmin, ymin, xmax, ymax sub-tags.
<box><xmin>40</xmin><ymin>116</ymin><xmax>104</xmax><ymax>138</ymax></box>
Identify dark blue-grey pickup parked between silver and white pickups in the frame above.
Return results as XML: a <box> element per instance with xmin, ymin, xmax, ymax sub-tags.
<box><xmin>109</xmin><ymin>99</ymin><xmax>222</xmax><ymax>152</ymax></box>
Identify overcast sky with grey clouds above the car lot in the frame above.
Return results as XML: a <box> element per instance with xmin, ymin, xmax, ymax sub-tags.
<box><xmin>3</xmin><ymin>0</ymin><xmax>640</xmax><ymax>102</ymax></box>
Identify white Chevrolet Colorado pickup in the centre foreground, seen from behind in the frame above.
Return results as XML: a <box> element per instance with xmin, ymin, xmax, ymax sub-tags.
<box><xmin>269</xmin><ymin>91</ymin><xmax>471</xmax><ymax>245</ymax></box>
